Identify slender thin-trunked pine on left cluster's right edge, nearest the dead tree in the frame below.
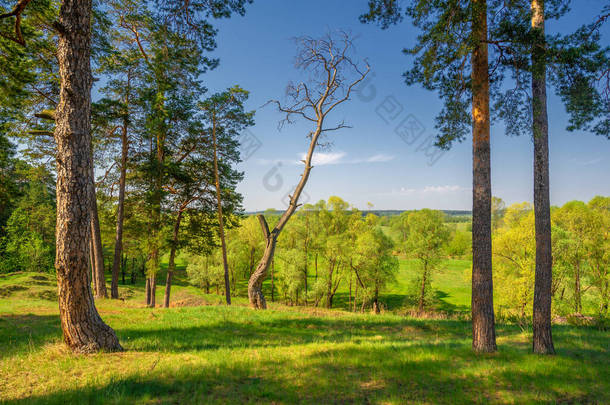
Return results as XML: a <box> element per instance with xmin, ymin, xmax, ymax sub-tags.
<box><xmin>200</xmin><ymin>86</ymin><xmax>254</xmax><ymax>305</ymax></box>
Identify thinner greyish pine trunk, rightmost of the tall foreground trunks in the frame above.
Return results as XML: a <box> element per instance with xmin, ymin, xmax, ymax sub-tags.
<box><xmin>531</xmin><ymin>0</ymin><xmax>555</xmax><ymax>354</ymax></box>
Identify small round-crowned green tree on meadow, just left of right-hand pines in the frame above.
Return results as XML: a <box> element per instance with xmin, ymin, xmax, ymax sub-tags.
<box><xmin>406</xmin><ymin>209</ymin><xmax>449</xmax><ymax>313</ymax></box>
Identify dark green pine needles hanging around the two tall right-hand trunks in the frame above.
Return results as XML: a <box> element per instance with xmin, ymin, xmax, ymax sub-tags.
<box><xmin>360</xmin><ymin>0</ymin><xmax>610</xmax><ymax>148</ymax></box>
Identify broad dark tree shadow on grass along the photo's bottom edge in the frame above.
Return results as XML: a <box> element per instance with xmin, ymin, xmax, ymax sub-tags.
<box><xmin>7</xmin><ymin>342</ymin><xmax>609</xmax><ymax>404</ymax></box>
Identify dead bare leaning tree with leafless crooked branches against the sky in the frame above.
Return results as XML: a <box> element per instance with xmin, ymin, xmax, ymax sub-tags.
<box><xmin>248</xmin><ymin>32</ymin><xmax>370</xmax><ymax>309</ymax></box>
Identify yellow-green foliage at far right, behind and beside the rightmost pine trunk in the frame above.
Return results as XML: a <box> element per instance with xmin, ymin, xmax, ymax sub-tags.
<box><xmin>493</xmin><ymin>196</ymin><xmax>610</xmax><ymax>319</ymax></box>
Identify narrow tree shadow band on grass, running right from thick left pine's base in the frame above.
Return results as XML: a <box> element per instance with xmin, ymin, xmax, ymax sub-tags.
<box><xmin>116</xmin><ymin>308</ymin><xmax>521</xmax><ymax>352</ymax></box>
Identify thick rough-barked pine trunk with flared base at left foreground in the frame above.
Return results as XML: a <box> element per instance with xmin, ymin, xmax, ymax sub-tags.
<box><xmin>54</xmin><ymin>0</ymin><xmax>122</xmax><ymax>353</ymax></box>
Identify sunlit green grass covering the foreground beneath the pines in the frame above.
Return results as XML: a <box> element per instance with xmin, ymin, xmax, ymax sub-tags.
<box><xmin>0</xmin><ymin>270</ymin><xmax>610</xmax><ymax>404</ymax></box>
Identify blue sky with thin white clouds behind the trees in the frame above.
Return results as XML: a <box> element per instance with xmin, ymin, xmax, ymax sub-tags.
<box><xmin>202</xmin><ymin>0</ymin><xmax>610</xmax><ymax>211</ymax></box>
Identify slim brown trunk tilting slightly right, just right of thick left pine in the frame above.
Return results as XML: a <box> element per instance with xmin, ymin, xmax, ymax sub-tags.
<box><xmin>110</xmin><ymin>117</ymin><xmax>129</xmax><ymax>299</ymax></box>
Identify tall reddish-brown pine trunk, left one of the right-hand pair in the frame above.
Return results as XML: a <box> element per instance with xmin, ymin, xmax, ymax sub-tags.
<box><xmin>472</xmin><ymin>0</ymin><xmax>497</xmax><ymax>352</ymax></box>
